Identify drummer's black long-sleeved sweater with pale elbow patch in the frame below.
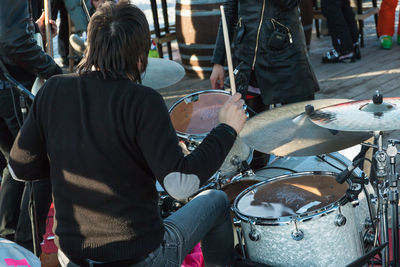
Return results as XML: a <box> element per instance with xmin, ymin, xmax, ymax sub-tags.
<box><xmin>9</xmin><ymin>72</ymin><xmax>236</xmax><ymax>261</ymax></box>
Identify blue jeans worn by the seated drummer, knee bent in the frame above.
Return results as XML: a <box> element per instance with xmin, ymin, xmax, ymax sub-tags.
<box><xmin>58</xmin><ymin>190</ymin><xmax>234</xmax><ymax>267</ymax></box>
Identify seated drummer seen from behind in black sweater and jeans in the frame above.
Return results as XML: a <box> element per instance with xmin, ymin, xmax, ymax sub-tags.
<box><xmin>9</xmin><ymin>1</ymin><xmax>246</xmax><ymax>267</ymax></box>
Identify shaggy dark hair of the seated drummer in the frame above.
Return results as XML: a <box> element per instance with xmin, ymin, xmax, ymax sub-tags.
<box><xmin>78</xmin><ymin>0</ymin><xmax>150</xmax><ymax>82</ymax></box>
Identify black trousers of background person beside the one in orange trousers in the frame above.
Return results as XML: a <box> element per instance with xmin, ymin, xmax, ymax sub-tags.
<box><xmin>321</xmin><ymin>0</ymin><xmax>359</xmax><ymax>55</ymax></box>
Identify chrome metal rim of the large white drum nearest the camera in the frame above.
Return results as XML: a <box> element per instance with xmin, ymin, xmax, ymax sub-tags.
<box><xmin>232</xmin><ymin>171</ymin><xmax>345</xmax><ymax>226</ymax></box>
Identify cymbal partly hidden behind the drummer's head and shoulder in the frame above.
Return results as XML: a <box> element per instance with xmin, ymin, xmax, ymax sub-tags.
<box><xmin>142</xmin><ymin>58</ymin><xmax>185</xmax><ymax>89</ymax></box>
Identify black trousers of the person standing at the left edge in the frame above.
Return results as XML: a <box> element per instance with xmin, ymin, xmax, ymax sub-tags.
<box><xmin>0</xmin><ymin>86</ymin><xmax>51</xmax><ymax>253</ymax></box>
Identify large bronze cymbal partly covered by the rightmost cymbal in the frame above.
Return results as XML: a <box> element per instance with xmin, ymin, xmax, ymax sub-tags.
<box><xmin>240</xmin><ymin>99</ymin><xmax>370</xmax><ymax>156</ymax></box>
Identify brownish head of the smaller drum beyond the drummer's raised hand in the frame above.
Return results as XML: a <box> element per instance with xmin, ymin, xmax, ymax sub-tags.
<box><xmin>169</xmin><ymin>90</ymin><xmax>230</xmax><ymax>135</ymax></box>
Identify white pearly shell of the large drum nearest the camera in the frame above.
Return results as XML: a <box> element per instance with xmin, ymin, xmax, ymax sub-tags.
<box><xmin>241</xmin><ymin>203</ymin><xmax>363</xmax><ymax>267</ymax></box>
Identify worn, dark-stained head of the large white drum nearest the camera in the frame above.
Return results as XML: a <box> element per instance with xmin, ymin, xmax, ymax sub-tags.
<box><xmin>235</xmin><ymin>173</ymin><xmax>348</xmax><ymax>219</ymax></box>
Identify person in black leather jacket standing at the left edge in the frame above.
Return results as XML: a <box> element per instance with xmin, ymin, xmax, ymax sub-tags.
<box><xmin>0</xmin><ymin>0</ymin><xmax>62</xmax><ymax>253</ymax></box>
